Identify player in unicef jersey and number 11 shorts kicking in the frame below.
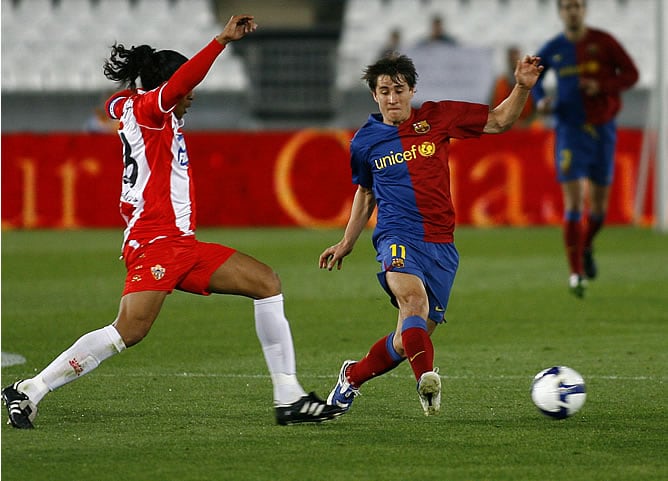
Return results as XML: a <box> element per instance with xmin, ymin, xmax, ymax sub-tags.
<box><xmin>320</xmin><ymin>51</ymin><xmax>542</xmax><ymax>415</ymax></box>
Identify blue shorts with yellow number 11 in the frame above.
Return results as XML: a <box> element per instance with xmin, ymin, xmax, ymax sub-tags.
<box><xmin>376</xmin><ymin>236</ymin><xmax>459</xmax><ymax>323</ymax></box>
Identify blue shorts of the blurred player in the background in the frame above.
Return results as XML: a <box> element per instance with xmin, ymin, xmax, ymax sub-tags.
<box><xmin>555</xmin><ymin>120</ymin><xmax>617</xmax><ymax>186</ymax></box>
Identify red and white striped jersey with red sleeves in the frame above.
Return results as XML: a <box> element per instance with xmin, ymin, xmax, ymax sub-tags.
<box><xmin>106</xmin><ymin>40</ymin><xmax>224</xmax><ymax>246</ymax></box>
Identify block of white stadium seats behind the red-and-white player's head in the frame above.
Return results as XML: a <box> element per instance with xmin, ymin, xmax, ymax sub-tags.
<box><xmin>2</xmin><ymin>0</ymin><xmax>247</xmax><ymax>92</ymax></box>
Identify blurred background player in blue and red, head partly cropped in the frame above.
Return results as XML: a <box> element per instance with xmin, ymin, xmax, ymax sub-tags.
<box><xmin>533</xmin><ymin>0</ymin><xmax>638</xmax><ymax>297</ymax></box>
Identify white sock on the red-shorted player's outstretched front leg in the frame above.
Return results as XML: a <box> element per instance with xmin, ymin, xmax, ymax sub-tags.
<box><xmin>254</xmin><ymin>294</ymin><xmax>306</xmax><ymax>406</ymax></box>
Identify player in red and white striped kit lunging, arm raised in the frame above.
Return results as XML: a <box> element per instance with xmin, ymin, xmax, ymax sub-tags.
<box><xmin>2</xmin><ymin>15</ymin><xmax>342</xmax><ymax>429</ymax></box>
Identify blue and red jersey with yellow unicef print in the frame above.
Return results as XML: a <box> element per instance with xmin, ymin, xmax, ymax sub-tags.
<box><xmin>350</xmin><ymin>101</ymin><xmax>489</xmax><ymax>245</ymax></box>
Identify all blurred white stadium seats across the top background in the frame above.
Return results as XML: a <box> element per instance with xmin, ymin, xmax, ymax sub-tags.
<box><xmin>2</xmin><ymin>0</ymin><xmax>657</xmax><ymax>91</ymax></box>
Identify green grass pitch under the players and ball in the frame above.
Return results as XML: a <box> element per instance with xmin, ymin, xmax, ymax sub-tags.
<box><xmin>2</xmin><ymin>227</ymin><xmax>668</xmax><ymax>481</ymax></box>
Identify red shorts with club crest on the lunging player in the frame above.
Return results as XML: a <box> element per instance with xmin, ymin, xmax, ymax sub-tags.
<box><xmin>123</xmin><ymin>236</ymin><xmax>236</xmax><ymax>296</ymax></box>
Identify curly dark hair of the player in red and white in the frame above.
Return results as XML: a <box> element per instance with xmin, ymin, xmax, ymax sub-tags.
<box><xmin>104</xmin><ymin>43</ymin><xmax>188</xmax><ymax>90</ymax></box>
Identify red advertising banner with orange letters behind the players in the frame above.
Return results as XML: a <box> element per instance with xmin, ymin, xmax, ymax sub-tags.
<box><xmin>2</xmin><ymin>130</ymin><xmax>652</xmax><ymax>228</ymax></box>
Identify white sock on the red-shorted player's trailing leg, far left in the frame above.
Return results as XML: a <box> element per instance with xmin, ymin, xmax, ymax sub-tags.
<box><xmin>18</xmin><ymin>325</ymin><xmax>125</xmax><ymax>404</ymax></box>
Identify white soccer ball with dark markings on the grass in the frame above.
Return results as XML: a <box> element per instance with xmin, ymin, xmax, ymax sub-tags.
<box><xmin>531</xmin><ymin>366</ymin><xmax>587</xmax><ymax>419</ymax></box>
